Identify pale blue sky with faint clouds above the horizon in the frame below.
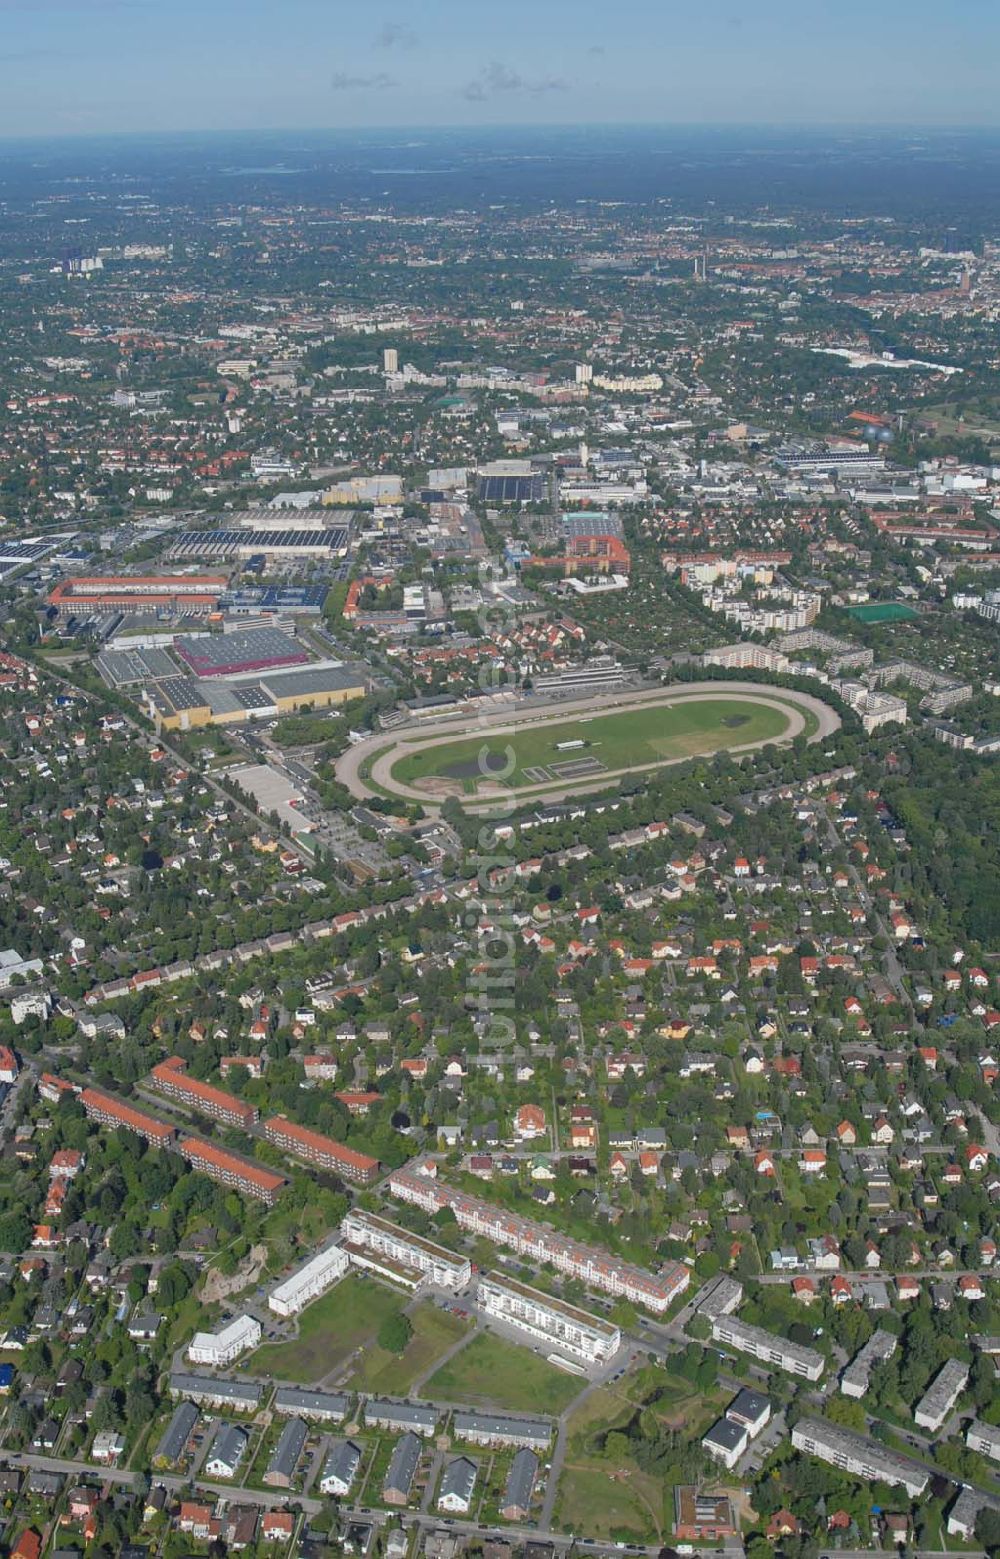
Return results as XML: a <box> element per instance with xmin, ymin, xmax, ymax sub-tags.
<box><xmin>0</xmin><ymin>0</ymin><xmax>1000</xmax><ymax>136</ymax></box>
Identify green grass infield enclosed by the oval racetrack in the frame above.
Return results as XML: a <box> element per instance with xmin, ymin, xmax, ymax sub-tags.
<box><xmin>392</xmin><ymin>697</ymin><xmax>791</xmax><ymax>794</ymax></box>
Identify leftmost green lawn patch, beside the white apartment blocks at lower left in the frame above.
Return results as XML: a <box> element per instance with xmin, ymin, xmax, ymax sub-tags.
<box><xmin>248</xmin><ymin>1274</ymin><xmax>406</xmax><ymax>1386</ymax></box>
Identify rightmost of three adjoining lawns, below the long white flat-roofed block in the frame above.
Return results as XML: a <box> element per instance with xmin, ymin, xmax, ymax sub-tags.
<box><xmin>423</xmin><ymin>1331</ymin><xmax>587</xmax><ymax>1414</ymax></box>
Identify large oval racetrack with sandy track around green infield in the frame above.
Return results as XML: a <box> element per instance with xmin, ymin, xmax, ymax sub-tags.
<box><xmin>337</xmin><ymin>681</ymin><xmax>841</xmax><ymax>811</ymax></box>
